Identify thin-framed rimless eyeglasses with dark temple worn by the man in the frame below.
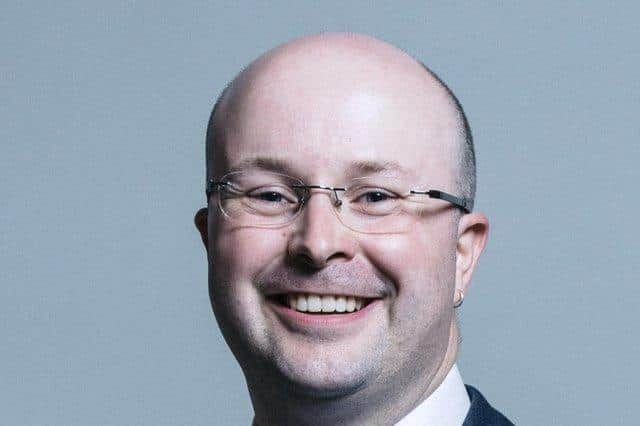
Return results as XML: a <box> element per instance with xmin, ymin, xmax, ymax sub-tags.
<box><xmin>206</xmin><ymin>170</ymin><xmax>471</xmax><ymax>234</ymax></box>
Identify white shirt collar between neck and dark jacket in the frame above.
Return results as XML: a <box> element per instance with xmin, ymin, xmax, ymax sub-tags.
<box><xmin>396</xmin><ymin>364</ymin><xmax>471</xmax><ymax>426</ymax></box>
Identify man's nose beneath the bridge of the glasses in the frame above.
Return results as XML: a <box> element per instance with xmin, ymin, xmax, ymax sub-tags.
<box><xmin>287</xmin><ymin>190</ymin><xmax>356</xmax><ymax>269</ymax></box>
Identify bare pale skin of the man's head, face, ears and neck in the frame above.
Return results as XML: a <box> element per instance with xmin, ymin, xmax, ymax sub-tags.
<box><xmin>196</xmin><ymin>34</ymin><xmax>489</xmax><ymax>425</ymax></box>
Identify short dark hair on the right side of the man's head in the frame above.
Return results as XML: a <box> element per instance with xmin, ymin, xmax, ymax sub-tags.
<box><xmin>416</xmin><ymin>59</ymin><xmax>476</xmax><ymax>210</ymax></box>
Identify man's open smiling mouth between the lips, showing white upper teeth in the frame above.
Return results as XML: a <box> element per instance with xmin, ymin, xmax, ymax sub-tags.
<box><xmin>267</xmin><ymin>293</ymin><xmax>376</xmax><ymax>315</ymax></box>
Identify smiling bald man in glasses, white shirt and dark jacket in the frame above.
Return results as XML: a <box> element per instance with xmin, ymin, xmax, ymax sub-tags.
<box><xmin>195</xmin><ymin>34</ymin><xmax>511</xmax><ymax>425</ymax></box>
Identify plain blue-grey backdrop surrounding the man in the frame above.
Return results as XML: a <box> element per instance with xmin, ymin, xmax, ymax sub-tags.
<box><xmin>0</xmin><ymin>0</ymin><xmax>640</xmax><ymax>425</ymax></box>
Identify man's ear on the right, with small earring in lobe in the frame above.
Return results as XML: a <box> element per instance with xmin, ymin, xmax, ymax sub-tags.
<box><xmin>454</xmin><ymin>212</ymin><xmax>489</xmax><ymax>303</ymax></box>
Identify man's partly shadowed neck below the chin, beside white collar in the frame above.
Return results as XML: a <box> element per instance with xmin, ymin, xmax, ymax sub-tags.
<box><xmin>249</xmin><ymin>319</ymin><xmax>459</xmax><ymax>426</ymax></box>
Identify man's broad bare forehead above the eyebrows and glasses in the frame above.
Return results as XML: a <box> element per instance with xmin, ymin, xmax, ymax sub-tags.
<box><xmin>212</xmin><ymin>46</ymin><xmax>459</xmax><ymax>186</ymax></box>
